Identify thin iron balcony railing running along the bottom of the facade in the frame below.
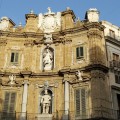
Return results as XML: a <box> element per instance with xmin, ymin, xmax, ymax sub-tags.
<box><xmin>0</xmin><ymin>107</ymin><xmax>120</xmax><ymax>120</ymax></box>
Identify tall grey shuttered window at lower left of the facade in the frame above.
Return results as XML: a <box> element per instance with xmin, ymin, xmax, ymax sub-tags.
<box><xmin>2</xmin><ymin>92</ymin><xmax>16</xmax><ymax>120</ymax></box>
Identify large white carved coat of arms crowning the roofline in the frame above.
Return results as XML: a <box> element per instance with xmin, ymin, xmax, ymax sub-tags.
<box><xmin>38</xmin><ymin>7</ymin><xmax>61</xmax><ymax>33</ymax></box>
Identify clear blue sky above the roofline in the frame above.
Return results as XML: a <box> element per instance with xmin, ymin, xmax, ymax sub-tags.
<box><xmin>0</xmin><ymin>0</ymin><xmax>120</xmax><ymax>26</ymax></box>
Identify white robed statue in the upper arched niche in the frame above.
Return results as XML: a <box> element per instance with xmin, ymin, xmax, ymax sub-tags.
<box><xmin>43</xmin><ymin>48</ymin><xmax>53</xmax><ymax>70</ymax></box>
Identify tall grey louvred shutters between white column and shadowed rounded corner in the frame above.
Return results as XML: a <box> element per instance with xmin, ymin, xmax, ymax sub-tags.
<box><xmin>75</xmin><ymin>88</ymin><xmax>87</xmax><ymax>119</ymax></box>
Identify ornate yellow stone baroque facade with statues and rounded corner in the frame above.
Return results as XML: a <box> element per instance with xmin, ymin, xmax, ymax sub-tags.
<box><xmin>0</xmin><ymin>8</ymin><xmax>116</xmax><ymax>120</ymax></box>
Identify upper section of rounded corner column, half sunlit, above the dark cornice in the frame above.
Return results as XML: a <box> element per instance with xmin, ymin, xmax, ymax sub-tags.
<box><xmin>88</xmin><ymin>28</ymin><xmax>106</xmax><ymax>65</ymax></box>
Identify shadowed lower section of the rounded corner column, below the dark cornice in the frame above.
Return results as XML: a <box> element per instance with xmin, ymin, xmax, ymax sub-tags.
<box><xmin>91</xmin><ymin>70</ymin><xmax>110</xmax><ymax>118</ymax></box>
